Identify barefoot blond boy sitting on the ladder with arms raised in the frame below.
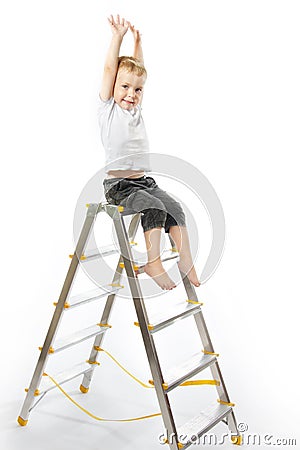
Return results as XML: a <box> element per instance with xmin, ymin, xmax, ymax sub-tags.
<box><xmin>99</xmin><ymin>15</ymin><xmax>200</xmax><ymax>290</ymax></box>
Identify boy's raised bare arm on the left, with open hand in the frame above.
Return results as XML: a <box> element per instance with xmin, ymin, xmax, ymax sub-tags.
<box><xmin>100</xmin><ymin>15</ymin><xmax>130</xmax><ymax>101</ymax></box>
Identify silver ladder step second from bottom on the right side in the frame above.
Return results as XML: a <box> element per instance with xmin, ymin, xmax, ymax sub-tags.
<box><xmin>164</xmin><ymin>353</ymin><xmax>217</xmax><ymax>392</ymax></box>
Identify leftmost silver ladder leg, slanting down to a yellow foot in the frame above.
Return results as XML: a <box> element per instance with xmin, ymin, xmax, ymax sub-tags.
<box><xmin>18</xmin><ymin>203</ymin><xmax>98</xmax><ymax>426</ymax></box>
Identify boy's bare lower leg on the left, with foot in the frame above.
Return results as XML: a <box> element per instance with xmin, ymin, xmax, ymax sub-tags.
<box><xmin>144</xmin><ymin>228</ymin><xmax>176</xmax><ymax>290</ymax></box>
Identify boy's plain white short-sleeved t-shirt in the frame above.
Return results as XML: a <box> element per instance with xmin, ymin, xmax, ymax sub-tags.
<box><xmin>98</xmin><ymin>97</ymin><xmax>151</xmax><ymax>172</ymax></box>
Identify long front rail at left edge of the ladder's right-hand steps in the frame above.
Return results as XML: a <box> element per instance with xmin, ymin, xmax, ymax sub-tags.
<box><xmin>113</xmin><ymin>212</ymin><xmax>178</xmax><ymax>450</ymax></box>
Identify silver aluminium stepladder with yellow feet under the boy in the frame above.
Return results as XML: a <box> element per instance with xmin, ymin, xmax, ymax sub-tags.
<box><xmin>18</xmin><ymin>203</ymin><xmax>242</xmax><ymax>450</ymax></box>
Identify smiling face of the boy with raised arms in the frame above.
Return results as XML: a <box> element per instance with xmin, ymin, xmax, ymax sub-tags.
<box><xmin>114</xmin><ymin>69</ymin><xmax>146</xmax><ymax>111</ymax></box>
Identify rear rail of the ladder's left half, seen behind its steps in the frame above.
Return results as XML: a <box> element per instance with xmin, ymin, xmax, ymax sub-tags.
<box><xmin>80</xmin><ymin>214</ymin><xmax>140</xmax><ymax>394</ymax></box>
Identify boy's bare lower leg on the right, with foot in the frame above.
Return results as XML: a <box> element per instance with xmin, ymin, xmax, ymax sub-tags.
<box><xmin>169</xmin><ymin>225</ymin><xmax>200</xmax><ymax>287</ymax></box>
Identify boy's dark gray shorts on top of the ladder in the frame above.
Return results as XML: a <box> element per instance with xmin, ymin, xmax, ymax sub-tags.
<box><xmin>103</xmin><ymin>176</ymin><xmax>185</xmax><ymax>233</ymax></box>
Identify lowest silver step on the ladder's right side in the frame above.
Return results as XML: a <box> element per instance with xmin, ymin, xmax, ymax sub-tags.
<box><xmin>177</xmin><ymin>404</ymin><xmax>232</xmax><ymax>449</ymax></box>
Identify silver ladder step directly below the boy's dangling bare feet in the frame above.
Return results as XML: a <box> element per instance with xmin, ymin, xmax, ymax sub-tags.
<box><xmin>144</xmin><ymin>302</ymin><xmax>201</xmax><ymax>333</ymax></box>
